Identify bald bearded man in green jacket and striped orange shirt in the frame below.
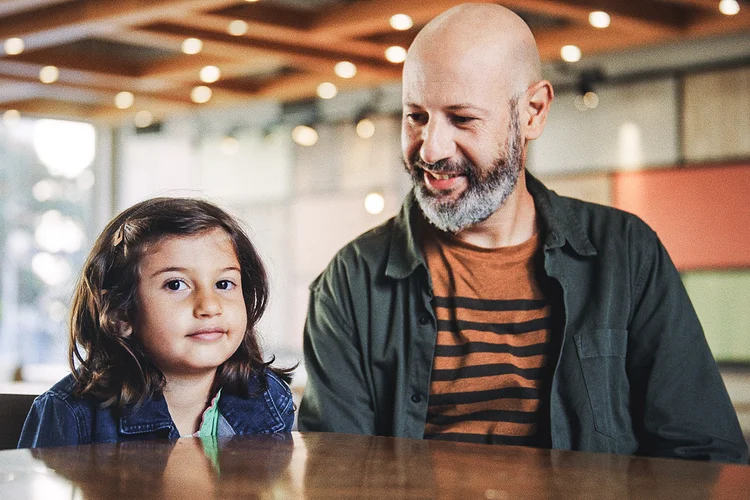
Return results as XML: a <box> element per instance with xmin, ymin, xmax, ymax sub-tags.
<box><xmin>299</xmin><ymin>4</ymin><xmax>747</xmax><ymax>462</ymax></box>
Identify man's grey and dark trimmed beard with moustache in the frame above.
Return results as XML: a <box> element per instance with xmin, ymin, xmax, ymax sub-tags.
<box><xmin>411</xmin><ymin>112</ymin><xmax>523</xmax><ymax>234</ymax></box>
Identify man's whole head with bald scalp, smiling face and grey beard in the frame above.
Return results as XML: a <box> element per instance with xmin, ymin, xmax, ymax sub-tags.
<box><xmin>401</xmin><ymin>4</ymin><xmax>554</xmax><ymax>233</ymax></box>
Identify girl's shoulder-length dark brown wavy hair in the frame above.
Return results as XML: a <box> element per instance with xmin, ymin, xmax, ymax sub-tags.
<box><xmin>69</xmin><ymin>198</ymin><xmax>294</xmax><ymax>407</ymax></box>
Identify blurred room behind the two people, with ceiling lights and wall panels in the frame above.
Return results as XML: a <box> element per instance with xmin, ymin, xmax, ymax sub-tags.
<box><xmin>0</xmin><ymin>0</ymin><xmax>750</xmax><ymax>434</ymax></box>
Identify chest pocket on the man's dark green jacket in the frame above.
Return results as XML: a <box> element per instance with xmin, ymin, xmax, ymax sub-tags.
<box><xmin>573</xmin><ymin>330</ymin><xmax>632</xmax><ymax>439</ymax></box>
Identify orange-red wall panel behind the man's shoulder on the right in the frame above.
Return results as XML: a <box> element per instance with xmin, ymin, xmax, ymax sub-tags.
<box><xmin>612</xmin><ymin>165</ymin><xmax>750</xmax><ymax>271</ymax></box>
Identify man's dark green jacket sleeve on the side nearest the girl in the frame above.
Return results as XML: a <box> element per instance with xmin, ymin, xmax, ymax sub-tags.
<box><xmin>299</xmin><ymin>266</ymin><xmax>376</xmax><ymax>434</ymax></box>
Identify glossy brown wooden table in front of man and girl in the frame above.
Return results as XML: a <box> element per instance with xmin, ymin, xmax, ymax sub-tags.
<box><xmin>0</xmin><ymin>433</ymin><xmax>750</xmax><ymax>500</ymax></box>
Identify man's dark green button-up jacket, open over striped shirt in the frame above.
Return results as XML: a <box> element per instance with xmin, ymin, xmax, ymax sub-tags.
<box><xmin>299</xmin><ymin>174</ymin><xmax>748</xmax><ymax>463</ymax></box>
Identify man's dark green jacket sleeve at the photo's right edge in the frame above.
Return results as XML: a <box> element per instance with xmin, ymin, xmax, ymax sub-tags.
<box><xmin>628</xmin><ymin>232</ymin><xmax>748</xmax><ymax>463</ymax></box>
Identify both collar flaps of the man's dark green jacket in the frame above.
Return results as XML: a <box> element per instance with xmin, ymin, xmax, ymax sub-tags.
<box><xmin>385</xmin><ymin>172</ymin><xmax>596</xmax><ymax>279</ymax></box>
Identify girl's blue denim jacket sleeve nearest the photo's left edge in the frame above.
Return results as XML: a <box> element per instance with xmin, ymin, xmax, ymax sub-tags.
<box><xmin>18</xmin><ymin>392</ymin><xmax>82</xmax><ymax>448</ymax></box>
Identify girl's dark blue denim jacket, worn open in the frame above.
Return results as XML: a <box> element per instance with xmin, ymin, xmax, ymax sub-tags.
<box><xmin>18</xmin><ymin>370</ymin><xmax>294</xmax><ymax>448</ymax></box>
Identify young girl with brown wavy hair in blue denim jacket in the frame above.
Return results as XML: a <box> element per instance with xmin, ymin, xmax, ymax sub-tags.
<box><xmin>18</xmin><ymin>198</ymin><xmax>294</xmax><ymax>448</ymax></box>
